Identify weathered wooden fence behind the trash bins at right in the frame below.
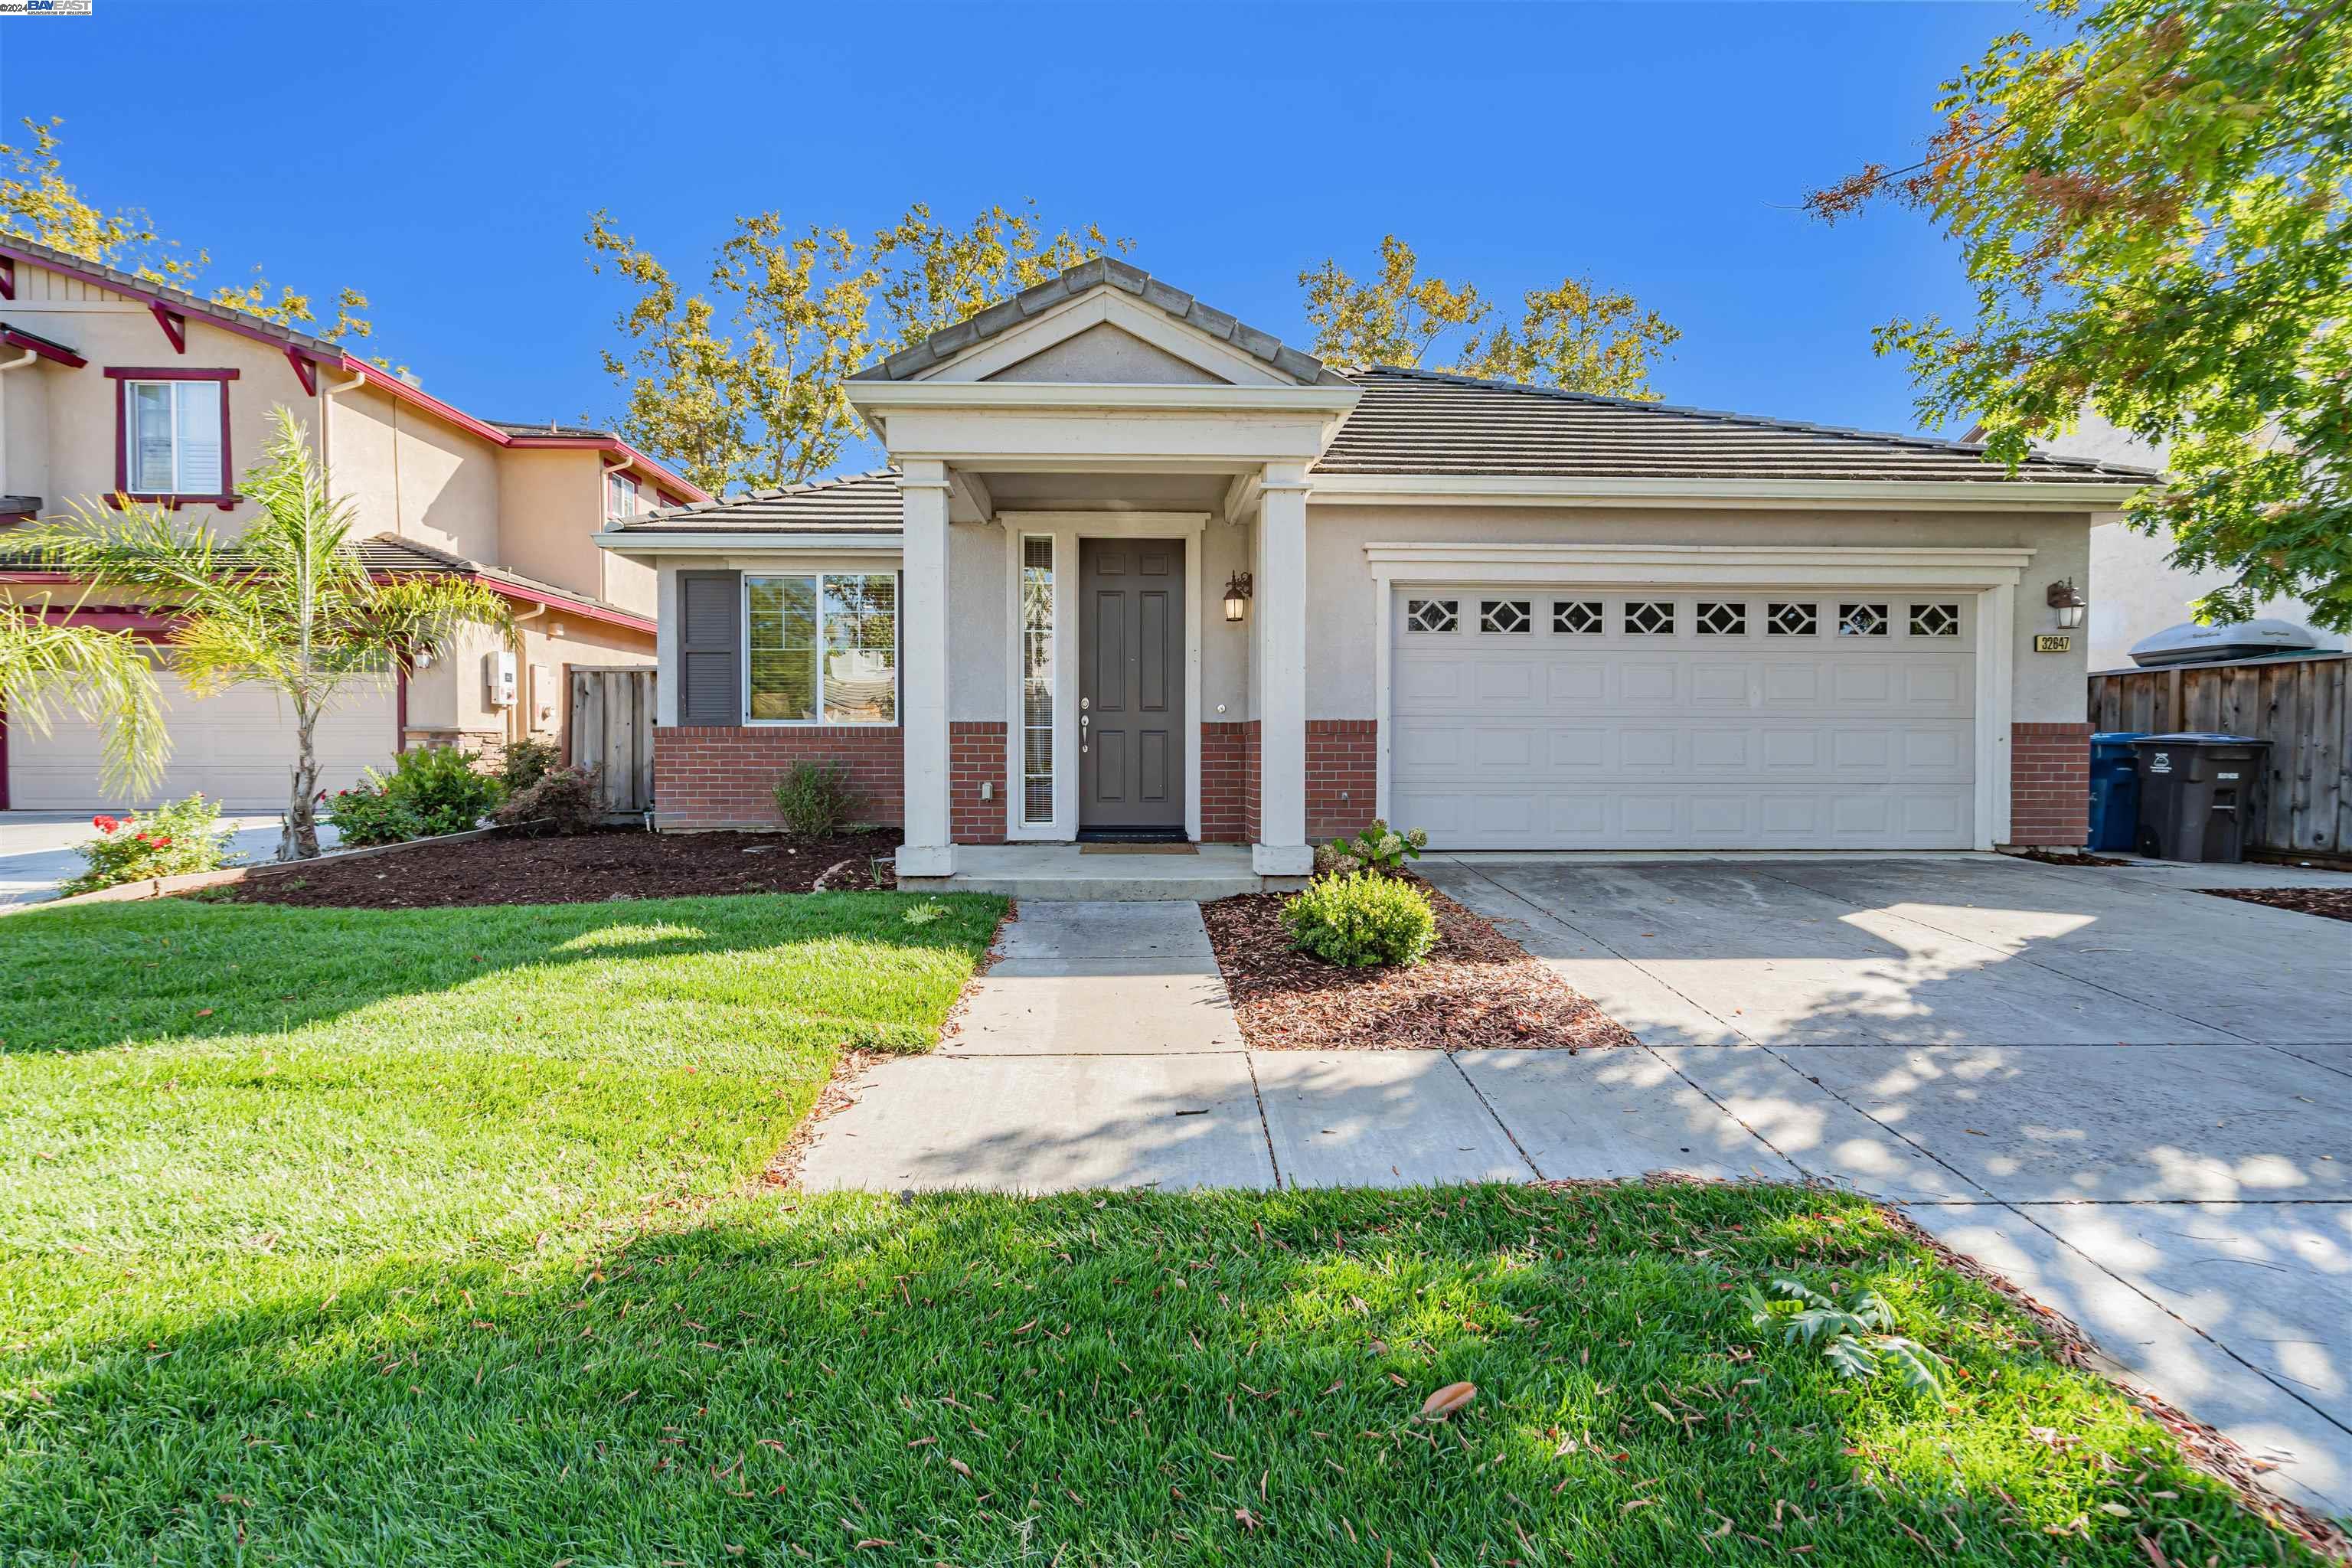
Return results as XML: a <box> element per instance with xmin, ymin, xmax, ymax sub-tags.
<box><xmin>2091</xmin><ymin>654</ymin><xmax>2352</xmax><ymax>861</ymax></box>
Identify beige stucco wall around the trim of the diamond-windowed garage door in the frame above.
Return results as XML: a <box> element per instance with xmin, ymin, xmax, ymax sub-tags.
<box><xmin>1308</xmin><ymin>503</ymin><xmax>2091</xmax><ymax>724</ymax></box>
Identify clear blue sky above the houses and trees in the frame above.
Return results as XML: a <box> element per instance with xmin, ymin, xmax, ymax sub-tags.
<box><xmin>0</xmin><ymin>0</ymin><xmax>2032</xmax><ymax>472</ymax></box>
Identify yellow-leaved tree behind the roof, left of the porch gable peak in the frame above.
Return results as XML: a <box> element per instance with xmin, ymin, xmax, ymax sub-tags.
<box><xmin>588</xmin><ymin>202</ymin><xmax>1126</xmax><ymax>492</ymax></box>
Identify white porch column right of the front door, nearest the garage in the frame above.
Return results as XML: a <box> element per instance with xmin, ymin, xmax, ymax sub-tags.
<box><xmin>1249</xmin><ymin>463</ymin><xmax>1315</xmax><ymax>877</ymax></box>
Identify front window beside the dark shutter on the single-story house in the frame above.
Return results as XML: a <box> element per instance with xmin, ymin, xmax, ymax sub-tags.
<box><xmin>743</xmin><ymin>571</ymin><xmax>899</xmax><ymax>724</ymax></box>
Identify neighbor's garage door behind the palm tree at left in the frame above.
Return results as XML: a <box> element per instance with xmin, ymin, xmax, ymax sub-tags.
<box><xmin>7</xmin><ymin>670</ymin><xmax>397</xmax><ymax>811</ymax></box>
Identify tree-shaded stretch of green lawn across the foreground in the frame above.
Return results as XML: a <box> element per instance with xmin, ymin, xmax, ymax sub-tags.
<box><xmin>0</xmin><ymin>1187</ymin><xmax>2317</xmax><ymax>1568</ymax></box>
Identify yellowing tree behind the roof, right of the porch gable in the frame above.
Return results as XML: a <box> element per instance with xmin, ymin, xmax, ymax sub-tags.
<box><xmin>1298</xmin><ymin>235</ymin><xmax>1681</xmax><ymax>397</ymax></box>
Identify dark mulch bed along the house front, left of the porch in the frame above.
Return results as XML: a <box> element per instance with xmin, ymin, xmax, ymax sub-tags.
<box><xmin>198</xmin><ymin>828</ymin><xmax>901</xmax><ymax>910</ymax></box>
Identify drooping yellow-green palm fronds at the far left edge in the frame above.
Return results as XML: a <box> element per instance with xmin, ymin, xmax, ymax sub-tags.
<box><xmin>0</xmin><ymin>604</ymin><xmax>172</xmax><ymax>795</ymax></box>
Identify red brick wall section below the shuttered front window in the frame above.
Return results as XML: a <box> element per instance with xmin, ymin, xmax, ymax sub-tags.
<box><xmin>654</xmin><ymin>724</ymin><xmax>906</xmax><ymax>832</ymax></box>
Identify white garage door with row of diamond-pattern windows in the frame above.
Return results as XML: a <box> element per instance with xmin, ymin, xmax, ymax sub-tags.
<box><xmin>1387</xmin><ymin>588</ymin><xmax>1975</xmax><ymax>848</ymax></box>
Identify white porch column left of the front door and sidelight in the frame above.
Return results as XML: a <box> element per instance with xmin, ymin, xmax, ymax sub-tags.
<box><xmin>899</xmin><ymin>459</ymin><xmax>955</xmax><ymax>877</ymax></box>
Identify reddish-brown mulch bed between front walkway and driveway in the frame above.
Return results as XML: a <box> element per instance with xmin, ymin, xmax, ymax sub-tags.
<box><xmin>1200</xmin><ymin>887</ymin><xmax>1635</xmax><ymax>1050</ymax></box>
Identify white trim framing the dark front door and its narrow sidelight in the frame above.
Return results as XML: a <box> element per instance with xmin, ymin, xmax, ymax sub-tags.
<box><xmin>998</xmin><ymin>512</ymin><xmax>1223</xmax><ymax>844</ymax></box>
